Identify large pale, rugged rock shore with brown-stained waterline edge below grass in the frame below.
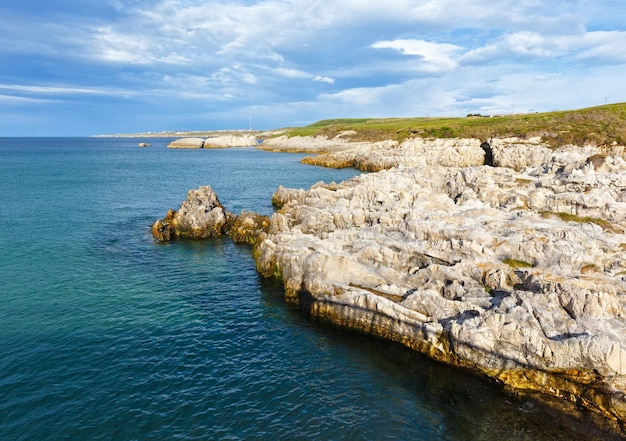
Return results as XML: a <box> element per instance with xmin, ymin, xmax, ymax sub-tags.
<box><xmin>153</xmin><ymin>137</ymin><xmax>626</xmax><ymax>434</ymax></box>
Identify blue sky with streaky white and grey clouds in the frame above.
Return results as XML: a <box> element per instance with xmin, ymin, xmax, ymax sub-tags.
<box><xmin>0</xmin><ymin>0</ymin><xmax>626</xmax><ymax>136</ymax></box>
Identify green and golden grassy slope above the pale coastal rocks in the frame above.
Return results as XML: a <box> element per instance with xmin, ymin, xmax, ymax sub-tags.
<box><xmin>288</xmin><ymin>103</ymin><xmax>626</xmax><ymax>147</ymax></box>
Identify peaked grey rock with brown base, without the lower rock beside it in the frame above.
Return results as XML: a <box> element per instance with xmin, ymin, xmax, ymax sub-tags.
<box><xmin>152</xmin><ymin>186</ymin><xmax>234</xmax><ymax>242</ymax></box>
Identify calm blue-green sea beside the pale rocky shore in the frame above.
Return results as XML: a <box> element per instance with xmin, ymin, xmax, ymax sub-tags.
<box><xmin>0</xmin><ymin>138</ymin><xmax>610</xmax><ymax>441</ymax></box>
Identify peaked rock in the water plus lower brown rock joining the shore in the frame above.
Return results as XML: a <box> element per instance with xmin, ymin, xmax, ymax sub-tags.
<box><xmin>151</xmin><ymin>186</ymin><xmax>269</xmax><ymax>245</ymax></box>
